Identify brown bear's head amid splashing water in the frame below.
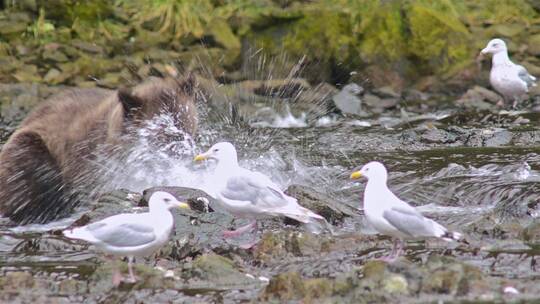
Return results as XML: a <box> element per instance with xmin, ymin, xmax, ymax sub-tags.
<box><xmin>109</xmin><ymin>74</ymin><xmax>197</xmax><ymax>137</ymax></box>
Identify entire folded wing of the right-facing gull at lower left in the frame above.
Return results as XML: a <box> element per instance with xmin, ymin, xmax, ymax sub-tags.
<box><xmin>86</xmin><ymin>214</ymin><xmax>156</xmax><ymax>247</ymax></box>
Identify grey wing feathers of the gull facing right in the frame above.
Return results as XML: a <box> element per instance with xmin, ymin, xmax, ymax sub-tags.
<box><xmin>87</xmin><ymin>222</ymin><xmax>156</xmax><ymax>247</ymax></box>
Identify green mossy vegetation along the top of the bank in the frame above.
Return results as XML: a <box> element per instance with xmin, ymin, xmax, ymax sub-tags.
<box><xmin>0</xmin><ymin>0</ymin><xmax>540</xmax><ymax>85</ymax></box>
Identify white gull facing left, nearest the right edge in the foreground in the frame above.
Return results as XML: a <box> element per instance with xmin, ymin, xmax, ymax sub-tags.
<box><xmin>351</xmin><ymin>161</ymin><xmax>461</xmax><ymax>261</ymax></box>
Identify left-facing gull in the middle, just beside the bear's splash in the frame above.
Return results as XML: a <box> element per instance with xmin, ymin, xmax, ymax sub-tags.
<box><xmin>194</xmin><ymin>142</ymin><xmax>324</xmax><ymax>248</ymax></box>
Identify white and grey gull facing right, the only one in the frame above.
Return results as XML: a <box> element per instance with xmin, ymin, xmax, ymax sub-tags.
<box><xmin>63</xmin><ymin>191</ymin><xmax>189</xmax><ymax>286</ymax></box>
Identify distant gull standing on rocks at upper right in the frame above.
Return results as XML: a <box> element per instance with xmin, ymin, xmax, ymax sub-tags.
<box><xmin>480</xmin><ymin>39</ymin><xmax>536</xmax><ymax>108</ymax></box>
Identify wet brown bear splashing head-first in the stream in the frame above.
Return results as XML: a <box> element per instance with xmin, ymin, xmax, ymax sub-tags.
<box><xmin>0</xmin><ymin>76</ymin><xmax>197</xmax><ymax>224</ymax></box>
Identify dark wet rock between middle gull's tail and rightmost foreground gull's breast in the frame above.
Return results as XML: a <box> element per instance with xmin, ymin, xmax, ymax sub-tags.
<box><xmin>286</xmin><ymin>185</ymin><xmax>359</xmax><ymax>225</ymax></box>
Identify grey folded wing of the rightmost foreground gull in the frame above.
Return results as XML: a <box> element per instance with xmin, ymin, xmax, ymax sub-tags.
<box><xmin>383</xmin><ymin>207</ymin><xmax>435</xmax><ymax>237</ymax></box>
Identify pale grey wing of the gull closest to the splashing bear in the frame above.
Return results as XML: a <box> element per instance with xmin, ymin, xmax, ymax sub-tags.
<box><xmin>221</xmin><ymin>176</ymin><xmax>287</xmax><ymax>208</ymax></box>
